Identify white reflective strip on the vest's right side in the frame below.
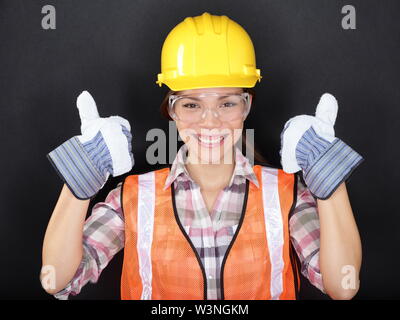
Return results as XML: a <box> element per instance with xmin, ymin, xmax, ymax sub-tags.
<box><xmin>261</xmin><ymin>168</ymin><xmax>284</xmax><ymax>300</ymax></box>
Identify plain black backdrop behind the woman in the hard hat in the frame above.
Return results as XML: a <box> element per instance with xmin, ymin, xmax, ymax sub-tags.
<box><xmin>0</xmin><ymin>0</ymin><xmax>400</xmax><ymax>299</ymax></box>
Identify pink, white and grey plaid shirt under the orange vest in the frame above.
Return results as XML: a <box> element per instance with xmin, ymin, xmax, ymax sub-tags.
<box><xmin>54</xmin><ymin>144</ymin><xmax>325</xmax><ymax>300</ymax></box>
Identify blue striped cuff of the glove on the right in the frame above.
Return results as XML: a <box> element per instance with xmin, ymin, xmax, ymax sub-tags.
<box><xmin>296</xmin><ymin>127</ymin><xmax>364</xmax><ymax>200</ymax></box>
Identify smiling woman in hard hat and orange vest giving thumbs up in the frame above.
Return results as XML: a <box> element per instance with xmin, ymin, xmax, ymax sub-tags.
<box><xmin>42</xmin><ymin>13</ymin><xmax>362</xmax><ymax>299</ymax></box>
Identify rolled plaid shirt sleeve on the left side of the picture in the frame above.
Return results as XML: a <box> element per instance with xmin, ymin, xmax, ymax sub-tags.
<box><xmin>53</xmin><ymin>183</ymin><xmax>125</xmax><ymax>300</ymax></box>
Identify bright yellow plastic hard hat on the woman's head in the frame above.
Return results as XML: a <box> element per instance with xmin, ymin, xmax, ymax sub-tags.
<box><xmin>156</xmin><ymin>12</ymin><xmax>261</xmax><ymax>91</ymax></box>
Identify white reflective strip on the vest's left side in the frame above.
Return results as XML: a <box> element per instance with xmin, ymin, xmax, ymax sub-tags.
<box><xmin>137</xmin><ymin>171</ymin><xmax>155</xmax><ymax>300</ymax></box>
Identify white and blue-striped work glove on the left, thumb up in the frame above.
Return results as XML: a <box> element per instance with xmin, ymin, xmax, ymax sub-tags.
<box><xmin>47</xmin><ymin>91</ymin><xmax>134</xmax><ymax>200</ymax></box>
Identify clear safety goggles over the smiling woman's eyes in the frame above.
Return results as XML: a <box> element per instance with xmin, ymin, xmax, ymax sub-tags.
<box><xmin>169</xmin><ymin>92</ymin><xmax>250</xmax><ymax>122</ymax></box>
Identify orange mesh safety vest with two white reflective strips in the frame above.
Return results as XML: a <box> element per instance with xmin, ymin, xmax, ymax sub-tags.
<box><xmin>121</xmin><ymin>165</ymin><xmax>300</xmax><ymax>300</ymax></box>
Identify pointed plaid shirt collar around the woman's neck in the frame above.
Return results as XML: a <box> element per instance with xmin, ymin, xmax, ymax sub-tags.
<box><xmin>164</xmin><ymin>144</ymin><xmax>259</xmax><ymax>190</ymax></box>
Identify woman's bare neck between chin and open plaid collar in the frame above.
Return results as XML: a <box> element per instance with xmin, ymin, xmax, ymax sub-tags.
<box><xmin>185</xmin><ymin>148</ymin><xmax>235</xmax><ymax>191</ymax></box>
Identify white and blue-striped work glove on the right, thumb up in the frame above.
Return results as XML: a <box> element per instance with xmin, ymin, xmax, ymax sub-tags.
<box><xmin>279</xmin><ymin>93</ymin><xmax>364</xmax><ymax>200</ymax></box>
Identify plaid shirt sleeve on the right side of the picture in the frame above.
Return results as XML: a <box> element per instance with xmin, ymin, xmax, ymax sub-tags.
<box><xmin>289</xmin><ymin>175</ymin><xmax>326</xmax><ymax>293</ymax></box>
